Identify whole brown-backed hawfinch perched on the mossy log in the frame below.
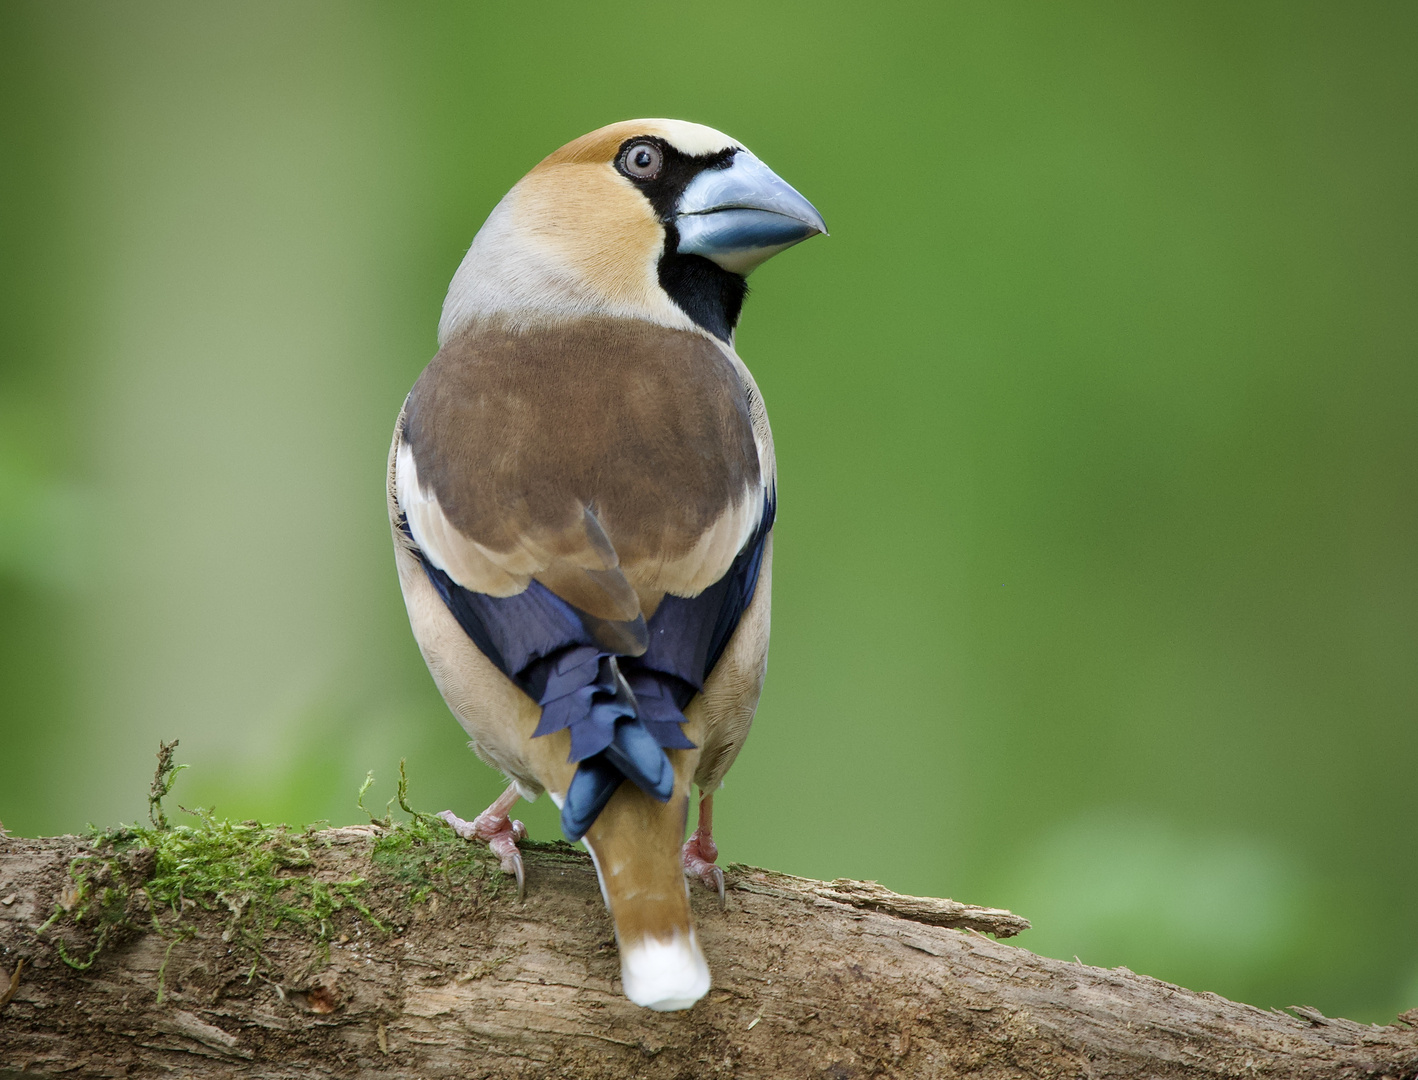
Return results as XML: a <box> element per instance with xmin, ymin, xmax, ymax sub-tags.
<box><xmin>387</xmin><ymin>119</ymin><xmax>827</xmax><ymax>1012</ymax></box>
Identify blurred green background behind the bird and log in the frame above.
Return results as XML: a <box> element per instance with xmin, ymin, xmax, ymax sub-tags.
<box><xmin>0</xmin><ymin>3</ymin><xmax>1418</xmax><ymax>1022</ymax></box>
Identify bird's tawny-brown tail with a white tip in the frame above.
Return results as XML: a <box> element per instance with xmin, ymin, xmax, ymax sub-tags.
<box><xmin>575</xmin><ymin>751</ymin><xmax>709</xmax><ymax>1012</ymax></box>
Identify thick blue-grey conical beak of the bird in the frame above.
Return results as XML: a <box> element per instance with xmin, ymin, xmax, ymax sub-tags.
<box><xmin>675</xmin><ymin>150</ymin><xmax>827</xmax><ymax>276</ymax></box>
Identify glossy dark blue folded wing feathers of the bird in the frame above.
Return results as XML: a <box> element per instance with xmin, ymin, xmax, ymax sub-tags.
<box><xmin>400</xmin><ymin>492</ymin><xmax>777</xmax><ymax>842</ymax></box>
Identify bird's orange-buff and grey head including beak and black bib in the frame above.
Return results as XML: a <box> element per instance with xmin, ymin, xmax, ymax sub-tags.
<box><xmin>438</xmin><ymin>120</ymin><xmax>827</xmax><ymax>343</ymax></box>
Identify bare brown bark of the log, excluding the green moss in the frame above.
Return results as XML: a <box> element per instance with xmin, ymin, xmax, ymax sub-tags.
<box><xmin>0</xmin><ymin>826</ymin><xmax>1418</xmax><ymax>1080</ymax></box>
